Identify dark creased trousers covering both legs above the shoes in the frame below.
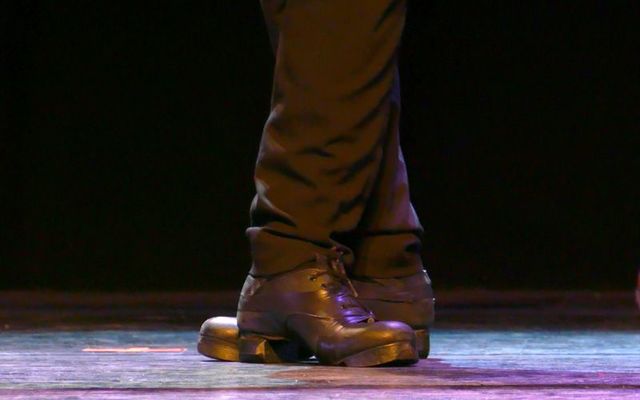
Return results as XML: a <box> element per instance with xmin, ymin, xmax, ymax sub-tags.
<box><xmin>247</xmin><ymin>0</ymin><xmax>422</xmax><ymax>278</ymax></box>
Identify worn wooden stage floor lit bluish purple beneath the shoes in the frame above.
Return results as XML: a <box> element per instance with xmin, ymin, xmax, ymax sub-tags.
<box><xmin>0</xmin><ymin>294</ymin><xmax>640</xmax><ymax>399</ymax></box>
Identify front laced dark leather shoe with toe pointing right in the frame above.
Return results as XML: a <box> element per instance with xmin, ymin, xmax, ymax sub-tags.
<box><xmin>232</xmin><ymin>260</ymin><xmax>418</xmax><ymax>366</ymax></box>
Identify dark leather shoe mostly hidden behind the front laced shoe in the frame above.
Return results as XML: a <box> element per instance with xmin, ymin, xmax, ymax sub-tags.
<box><xmin>198</xmin><ymin>271</ymin><xmax>434</xmax><ymax>361</ymax></box>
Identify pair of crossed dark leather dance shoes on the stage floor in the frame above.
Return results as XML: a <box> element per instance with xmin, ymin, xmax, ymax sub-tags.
<box><xmin>198</xmin><ymin>257</ymin><xmax>434</xmax><ymax>367</ymax></box>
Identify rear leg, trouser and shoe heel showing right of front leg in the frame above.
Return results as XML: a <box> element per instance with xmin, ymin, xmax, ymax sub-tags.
<box><xmin>352</xmin><ymin>66</ymin><xmax>434</xmax><ymax>358</ymax></box>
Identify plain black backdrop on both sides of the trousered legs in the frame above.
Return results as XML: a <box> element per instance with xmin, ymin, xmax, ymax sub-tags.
<box><xmin>0</xmin><ymin>0</ymin><xmax>640</xmax><ymax>291</ymax></box>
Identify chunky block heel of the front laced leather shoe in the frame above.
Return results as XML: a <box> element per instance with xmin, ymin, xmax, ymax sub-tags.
<box><xmin>238</xmin><ymin>334</ymin><xmax>302</xmax><ymax>364</ymax></box>
